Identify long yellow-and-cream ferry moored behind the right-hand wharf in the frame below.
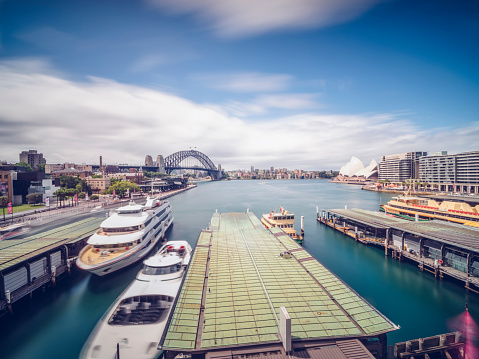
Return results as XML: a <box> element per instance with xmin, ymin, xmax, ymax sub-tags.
<box><xmin>380</xmin><ymin>192</ymin><xmax>479</xmax><ymax>227</ymax></box>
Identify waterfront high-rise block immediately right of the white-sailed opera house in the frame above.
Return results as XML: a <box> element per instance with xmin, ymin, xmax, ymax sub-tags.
<box><xmin>378</xmin><ymin>152</ymin><xmax>427</xmax><ymax>182</ymax></box>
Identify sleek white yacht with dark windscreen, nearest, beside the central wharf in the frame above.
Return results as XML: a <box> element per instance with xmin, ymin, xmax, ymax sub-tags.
<box><xmin>80</xmin><ymin>241</ymin><xmax>191</xmax><ymax>359</ymax></box>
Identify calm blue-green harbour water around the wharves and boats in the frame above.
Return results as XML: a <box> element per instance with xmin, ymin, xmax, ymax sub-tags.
<box><xmin>0</xmin><ymin>180</ymin><xmax>479</xmax><ymax>359</ymax></box>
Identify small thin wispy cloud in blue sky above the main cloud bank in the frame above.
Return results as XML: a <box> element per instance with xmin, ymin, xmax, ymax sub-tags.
<box><xmin>198</xmin><ymin>72</ymin><xmax>293</xmax><ymax>93</ymax></box>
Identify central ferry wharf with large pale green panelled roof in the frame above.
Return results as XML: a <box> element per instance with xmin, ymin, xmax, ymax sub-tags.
<box><xmin>159</xmin><ymin>211</ymin><xmax>398</xmax><ymax>359</ymax></box>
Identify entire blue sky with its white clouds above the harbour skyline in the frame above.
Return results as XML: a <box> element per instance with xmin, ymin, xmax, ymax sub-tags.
<box><xmin>0</xmin><ymin>0</ymin><xmax>479</xmax><ymax>169</ymax></box>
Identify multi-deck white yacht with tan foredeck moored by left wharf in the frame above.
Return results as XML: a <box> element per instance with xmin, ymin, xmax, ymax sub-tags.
<box><xmin>76</xmin><ymin>197</ymin><xmax>173</xmax><ymax>276</ymax></box>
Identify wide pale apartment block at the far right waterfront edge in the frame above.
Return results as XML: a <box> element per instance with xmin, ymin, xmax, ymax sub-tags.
<box><xmin>419</xmin><ymin>151</ymin><xmax>479</xmax><ymax>193</ymax></box>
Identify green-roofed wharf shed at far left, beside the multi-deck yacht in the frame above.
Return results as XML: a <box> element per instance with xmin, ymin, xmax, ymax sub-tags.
<box><xmin>0</xmin><ymin>217</ymin><xmax>102</xmax><ymax>316</ymax></box>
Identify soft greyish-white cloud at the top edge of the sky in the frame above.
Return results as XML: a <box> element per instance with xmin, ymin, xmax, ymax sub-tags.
<box><xmin>146</xmin><ymin>0</ymin><xmax>381</xmax><ymax>38</ymax></box>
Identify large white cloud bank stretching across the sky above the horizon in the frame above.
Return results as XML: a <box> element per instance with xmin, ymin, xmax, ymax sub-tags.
<box><xmin>0</xmin><ymin>60</ymin><xmax>479</xmax><ymax>169</ymax></box>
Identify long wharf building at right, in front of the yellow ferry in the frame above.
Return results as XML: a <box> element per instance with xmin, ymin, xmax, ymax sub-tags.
<box><xmin>317</xmin><ymin>209</ymin><xmax>479</xmax><ymax>294</ymax></box>
